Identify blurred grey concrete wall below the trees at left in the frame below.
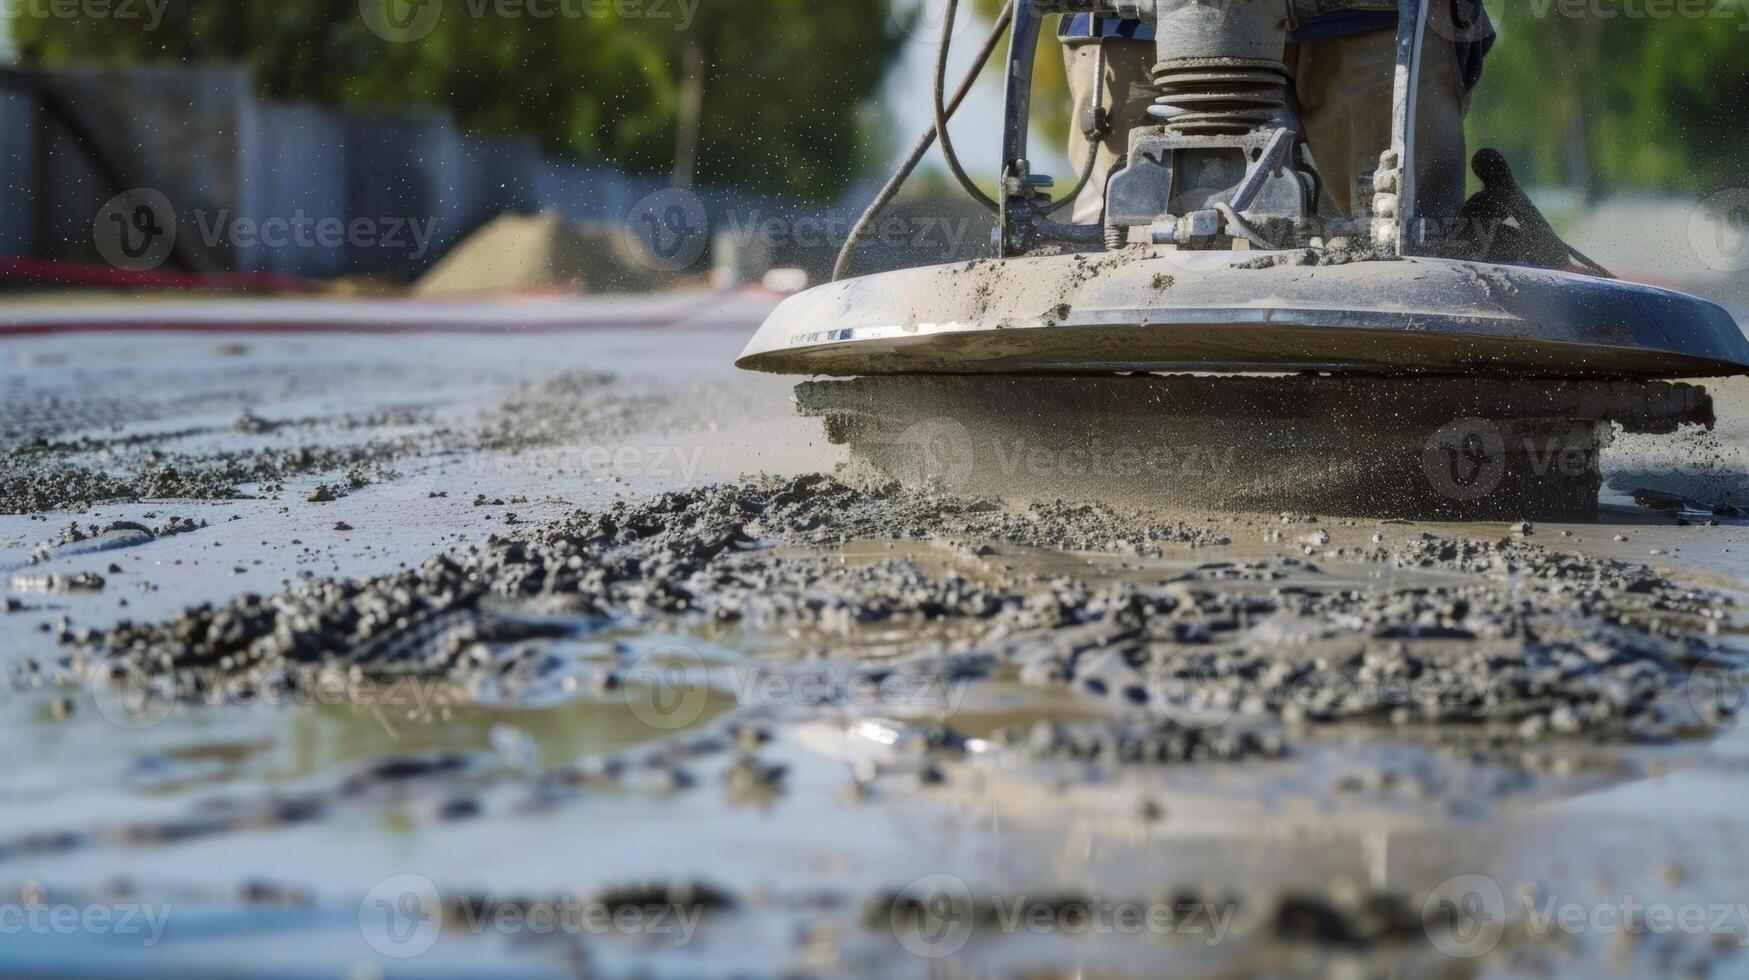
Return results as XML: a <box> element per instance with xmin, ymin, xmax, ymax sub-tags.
<box><xmin>0</xmin><ymin>68</ymin><xmax>836</xmax><ymax>278</ymax></box>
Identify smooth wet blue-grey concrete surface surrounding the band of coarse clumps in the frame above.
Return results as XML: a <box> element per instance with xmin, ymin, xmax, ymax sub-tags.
<box><xmin>0</xmin><ymin>296</ymin><xmax>1749</xmax><ymax>977</ymax></box>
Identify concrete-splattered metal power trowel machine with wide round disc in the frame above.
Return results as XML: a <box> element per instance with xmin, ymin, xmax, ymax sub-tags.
<box><xmin>738</xmin><ymin>0</ymin><xmax>1749</xmax><ymax>520</ymax></box>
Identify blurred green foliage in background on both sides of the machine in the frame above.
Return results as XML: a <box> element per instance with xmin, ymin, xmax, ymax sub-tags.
<box><xmin>14</xmin><ymin>0</ymin><xmax>1749</xmax><ymax>200</ymax></box>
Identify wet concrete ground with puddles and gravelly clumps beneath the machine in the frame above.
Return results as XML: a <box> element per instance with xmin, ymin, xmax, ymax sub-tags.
<box><xmin>0</xmin><ymin>311</ymin><xmax>1749</xmax><ymax>977</ymax></box>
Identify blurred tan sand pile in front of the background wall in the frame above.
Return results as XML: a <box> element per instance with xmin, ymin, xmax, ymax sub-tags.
<box><xmin>413</xmin><ymin>212</ymin><xmax>665</xmax><ymax>296</ymax></box>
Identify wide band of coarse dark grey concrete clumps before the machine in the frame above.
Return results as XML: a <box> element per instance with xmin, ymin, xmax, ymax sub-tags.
<box><xmin>23</xmin><ymin>476</ymin><xmax>1726</xmax><ymax>749</ymax></box>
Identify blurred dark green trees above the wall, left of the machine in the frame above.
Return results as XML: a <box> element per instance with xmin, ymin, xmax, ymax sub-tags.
<box><xmin>14</xmin><ymin>0</ymin><xmax>901</xmax><ymax>200</ymax></box>
